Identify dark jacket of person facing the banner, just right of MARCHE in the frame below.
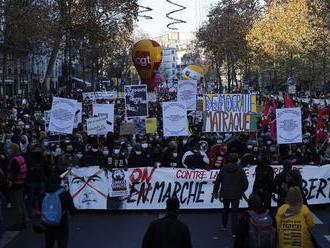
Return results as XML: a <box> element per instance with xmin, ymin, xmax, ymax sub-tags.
<box><xmin>213</xmin><ymin>163</ymin><xmax>249</xmax><ymax>200</ymax></box>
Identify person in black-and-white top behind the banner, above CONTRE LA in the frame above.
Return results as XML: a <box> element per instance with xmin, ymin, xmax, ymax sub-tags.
<box><xmin>182</xmin><ymin>142</ymin><xmax>210</xmax><ymax>169</ymax></box>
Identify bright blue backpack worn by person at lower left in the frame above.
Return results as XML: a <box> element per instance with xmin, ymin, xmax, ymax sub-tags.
<box><xmin>41</xmin><ymin>188</ymin><xmax>65</xmax><ymax>226</ymax></box>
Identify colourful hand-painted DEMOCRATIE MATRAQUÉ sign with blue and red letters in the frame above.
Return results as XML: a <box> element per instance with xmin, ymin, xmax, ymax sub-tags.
<box><xmin>203</xmin><ymin>94</ymin><xmax>257</xmax><ymax>132</ymax></box>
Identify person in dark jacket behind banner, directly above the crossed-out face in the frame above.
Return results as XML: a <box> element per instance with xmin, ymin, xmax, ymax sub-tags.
<box><xmin>80</xmin><ymin>142</ymin><xmax>107</xmax><ymax>167</ymax></box>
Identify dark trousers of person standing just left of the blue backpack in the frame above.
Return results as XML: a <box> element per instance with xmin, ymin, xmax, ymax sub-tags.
<box><xmin>27</xmin><ymin>181</ymin><xmax>46</xmax><ymax>218</ymax></box>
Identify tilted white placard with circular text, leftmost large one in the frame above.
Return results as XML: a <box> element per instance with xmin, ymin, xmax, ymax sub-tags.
<box><xmin>48</xmin><ymin>97</ymin><xmax>77</xmax><ymax>134</ymax></box>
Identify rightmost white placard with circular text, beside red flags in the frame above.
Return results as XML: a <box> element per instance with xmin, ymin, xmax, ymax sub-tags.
<box><xmin>276</xmin><ymin>108</ymin><xmax>302</xmax><ymax>144</ymax></box>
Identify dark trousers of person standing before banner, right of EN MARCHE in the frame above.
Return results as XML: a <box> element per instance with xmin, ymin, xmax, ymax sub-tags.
<box><xmin>222</xmin><ymin>199</ymin><xmax>239</xmax><ymax>235</ymax></box>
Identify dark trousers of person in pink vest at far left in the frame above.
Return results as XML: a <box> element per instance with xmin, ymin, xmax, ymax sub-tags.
<box><xmin>10</xmin><ymin>187</ymin><xmax>25</xmax><ymax>226</ymax></box>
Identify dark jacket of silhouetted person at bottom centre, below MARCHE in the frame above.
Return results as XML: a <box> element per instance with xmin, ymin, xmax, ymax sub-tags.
<box><xmin>142</xmin><ymin>214</ymin><xmax>192</xmax><ymax>248</ymax></box>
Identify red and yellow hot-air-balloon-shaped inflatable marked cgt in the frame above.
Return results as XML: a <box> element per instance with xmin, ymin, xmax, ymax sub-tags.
<box><xmin>132</xmin><ymin>40</ymin><xmax>163</xmax><ymax>88</ymax></box>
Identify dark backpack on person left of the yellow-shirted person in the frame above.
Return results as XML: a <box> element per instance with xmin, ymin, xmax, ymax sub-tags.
<box><xmin>248</xmin><ymin>210</ymin><xmax>275</xmax><ymax>248</ymax></box>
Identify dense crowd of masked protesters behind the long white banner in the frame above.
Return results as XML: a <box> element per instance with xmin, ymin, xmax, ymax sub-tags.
<box><xmin>0</xmin><ymin>85</ymin><xmax>330</xmax><ymax>248</ymax></box>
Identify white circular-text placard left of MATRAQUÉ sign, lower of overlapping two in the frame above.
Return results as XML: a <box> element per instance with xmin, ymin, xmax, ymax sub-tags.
<box><xmin>163</xmin><ymin>102</ymin><xmax>188</xmax><ymax>137</ymax></box>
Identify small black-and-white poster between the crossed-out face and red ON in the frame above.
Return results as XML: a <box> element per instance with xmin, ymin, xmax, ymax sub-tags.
<box><xmin>109</xmin><ymin>169</ymin><xmax>129</xmax><ymax>197</ymax></box>
